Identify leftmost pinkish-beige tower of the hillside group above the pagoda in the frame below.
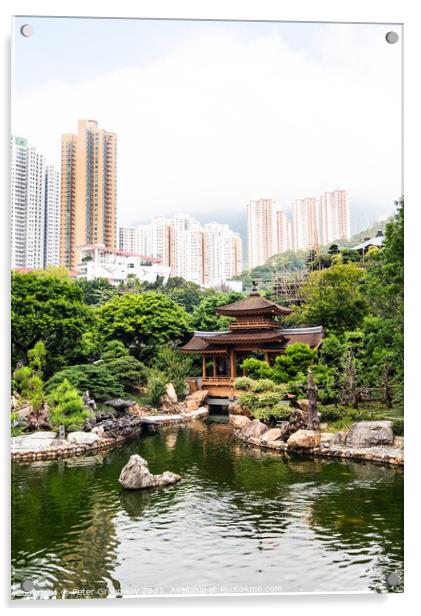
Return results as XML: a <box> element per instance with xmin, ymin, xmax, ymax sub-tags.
<box><xmin>247</xmin><ymin>199</ymin><xmax>276</xmax><ymax>269</ymax></box>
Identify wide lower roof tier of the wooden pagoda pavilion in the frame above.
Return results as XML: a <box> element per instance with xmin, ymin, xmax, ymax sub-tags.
<box><xmin>180</xmin><ymin>327</ymin><xmax>323</xmax><ymax>353</ymax></box>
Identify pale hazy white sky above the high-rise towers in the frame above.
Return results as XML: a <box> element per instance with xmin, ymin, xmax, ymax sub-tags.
<box><xmin>12</xmin><ymin>17</ymin><xmax>401</xmax><ymax>232</ymax></box>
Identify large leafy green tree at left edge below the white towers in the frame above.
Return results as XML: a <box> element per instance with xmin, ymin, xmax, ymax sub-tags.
<box><xmin>11</xmin><ymin>272</ymin><xmax>94</xmax><ymax>376</ymax></box>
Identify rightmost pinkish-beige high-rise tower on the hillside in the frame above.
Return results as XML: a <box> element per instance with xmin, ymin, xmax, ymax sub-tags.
<box><xmin>319</xmin><ymin>190</ymin><xmax>350</xmax><ymax>244</ymax></box>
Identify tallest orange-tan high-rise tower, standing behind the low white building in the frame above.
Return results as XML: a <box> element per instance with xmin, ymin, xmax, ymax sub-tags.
<box><xmin>60</xmin><ymin>120</ymin><xmax>117</xmax><ymax>267</ymax></box>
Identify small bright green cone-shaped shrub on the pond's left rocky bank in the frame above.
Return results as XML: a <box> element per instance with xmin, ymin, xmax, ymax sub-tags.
<box><xmin>47</xmin><ymin>379</ymin><xmax>91</xmax><ymax>432</ymax></box>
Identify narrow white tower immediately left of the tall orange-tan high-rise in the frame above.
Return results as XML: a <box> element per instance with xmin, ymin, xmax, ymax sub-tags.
<box><xmin>44</xmin><ymin>165</ymin><xmax>60</xmax><ymax>267</ymax></box>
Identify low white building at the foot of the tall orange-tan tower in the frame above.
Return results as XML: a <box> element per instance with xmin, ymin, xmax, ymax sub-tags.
<box><xmin>77</xmin><ymin>244</ymin><xmax>171</xmax><ymax>285</ymax></box>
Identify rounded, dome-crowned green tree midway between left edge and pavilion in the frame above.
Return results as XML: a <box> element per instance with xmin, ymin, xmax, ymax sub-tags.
<box><xmin>98</xmin><ymin>291</ymin><xmax>192</xmax><ymax>361</ymax></box>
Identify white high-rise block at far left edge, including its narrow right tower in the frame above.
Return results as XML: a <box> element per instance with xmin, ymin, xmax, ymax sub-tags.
<box><xmin>11</xmin><ymin>136</ymin><xmax>60</xmax><ymax>269</ymax></box>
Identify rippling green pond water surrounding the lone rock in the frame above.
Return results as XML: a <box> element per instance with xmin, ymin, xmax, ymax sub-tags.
<box><xmin>12</xmin><ymin>420</ymin><xmax>403</xmax><ymax>598</ymax></box>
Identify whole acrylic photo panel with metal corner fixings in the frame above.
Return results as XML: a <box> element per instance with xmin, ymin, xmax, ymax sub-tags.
<box><xmin>10</xmin><ymin>16</ymin><xmax>404</xmax><ymax>600</ymax></box>
